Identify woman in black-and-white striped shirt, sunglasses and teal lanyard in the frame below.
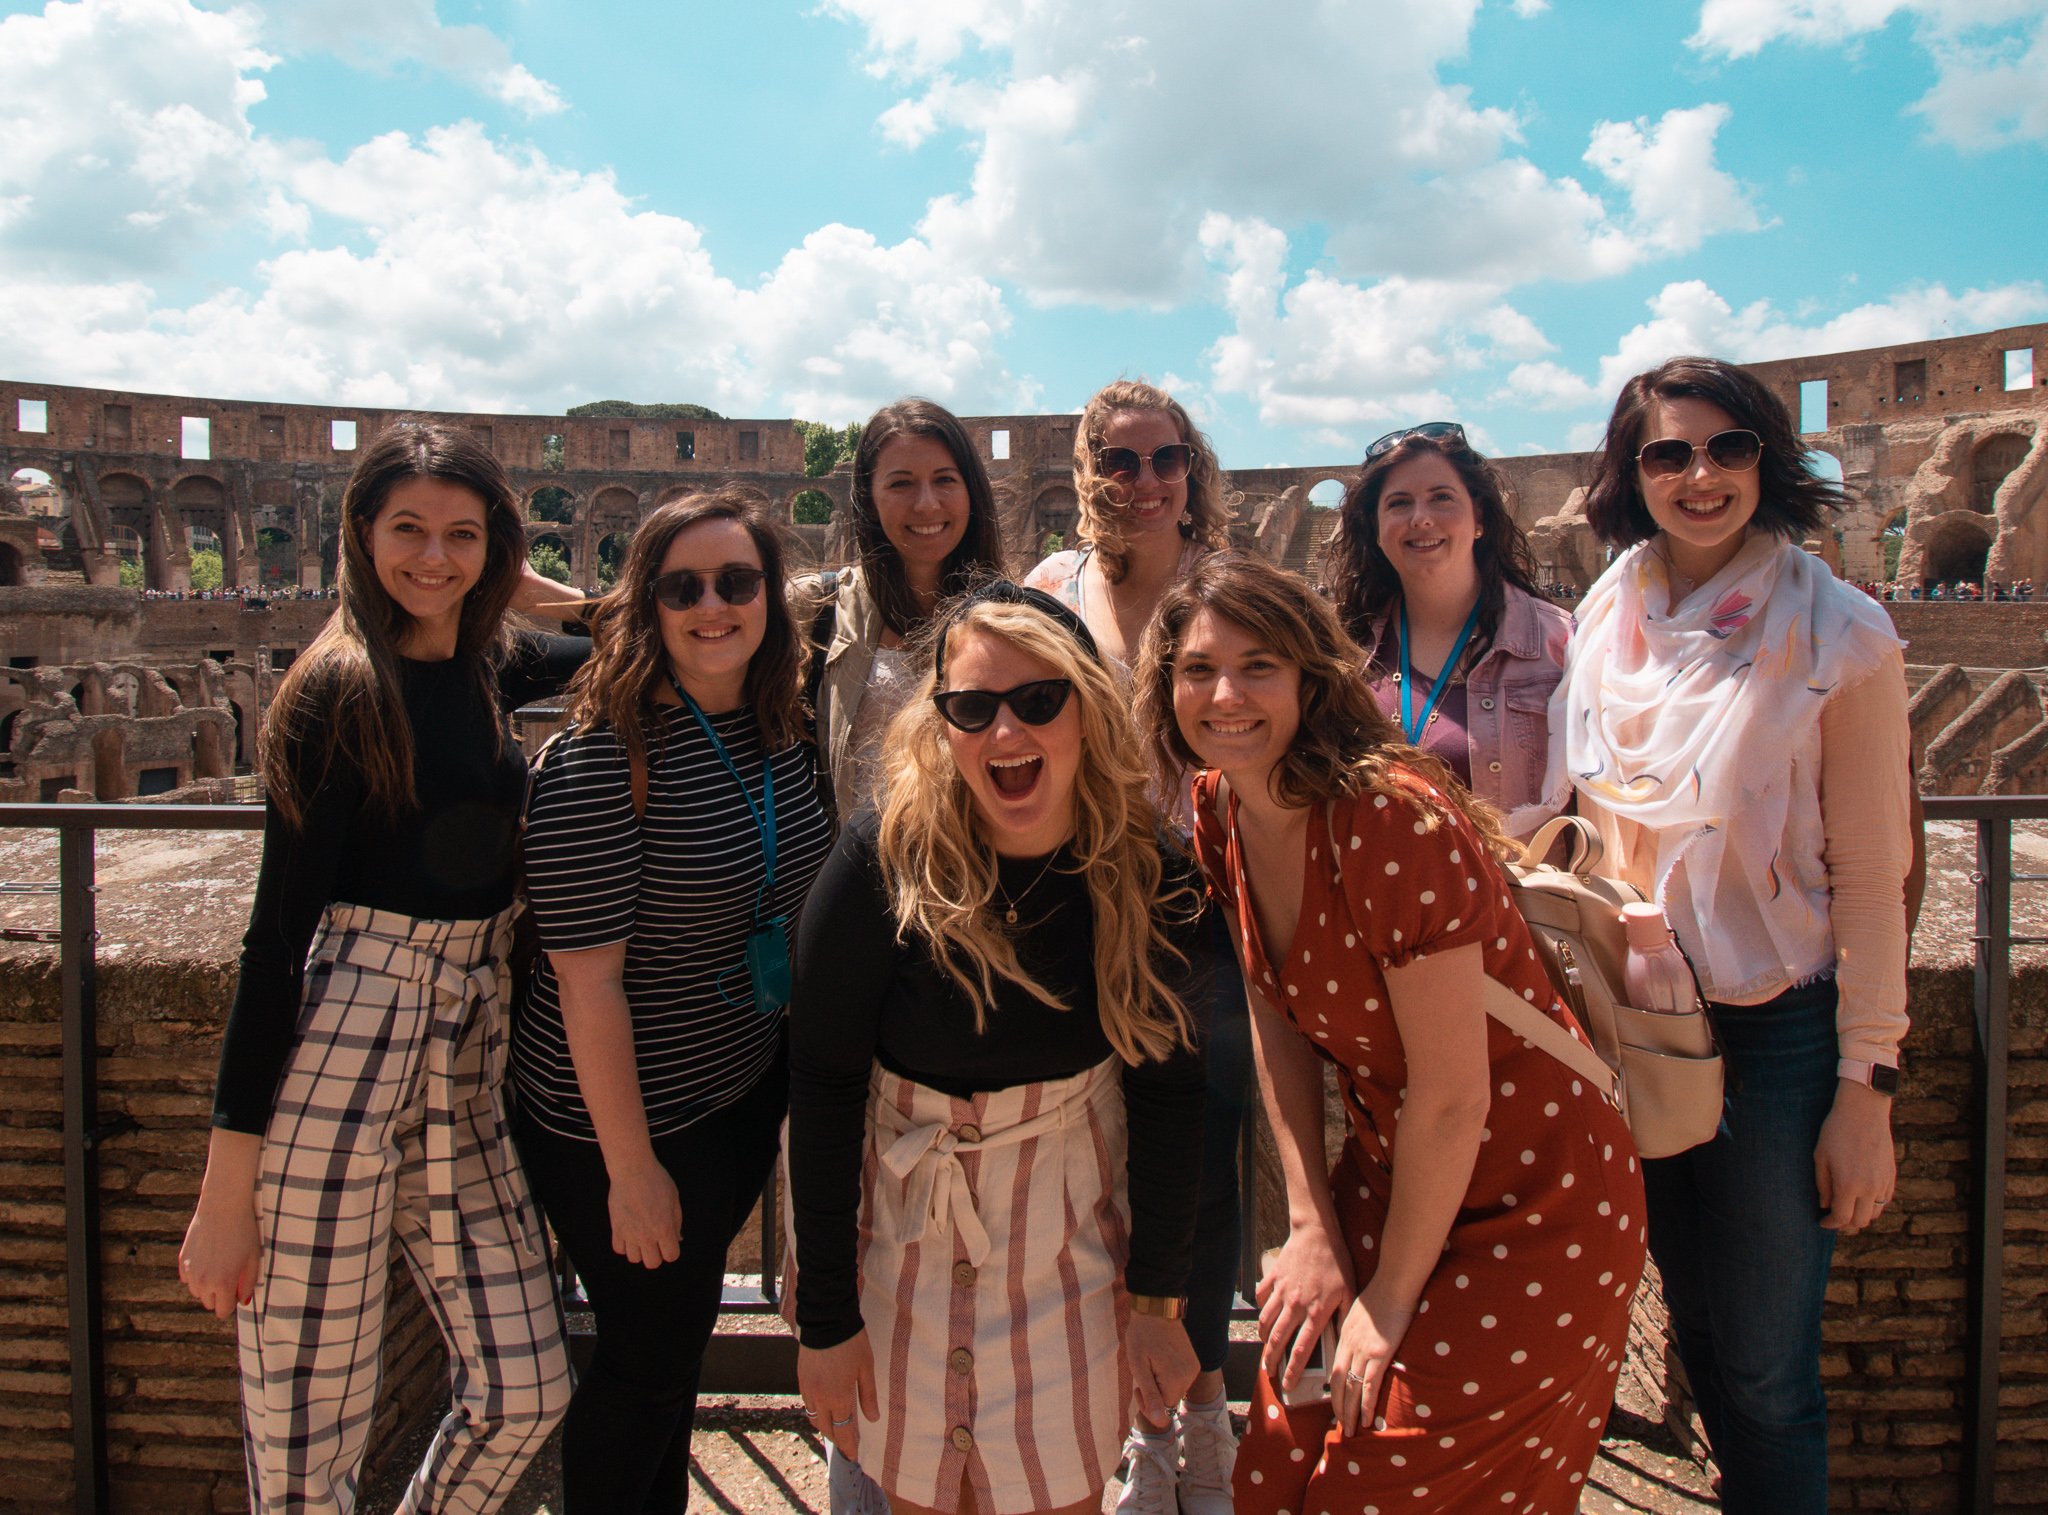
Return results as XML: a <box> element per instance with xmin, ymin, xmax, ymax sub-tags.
<box><xmin>512</xmin><ymin>487</ymin><xmax>831</xmax><ymax>1515</ymax></box>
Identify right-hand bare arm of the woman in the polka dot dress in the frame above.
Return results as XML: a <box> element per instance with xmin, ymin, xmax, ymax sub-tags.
<box><xmin>1331</xmin><ymin>946</ymin><xmax>1493</xmax><ymax>1435</ymax></box>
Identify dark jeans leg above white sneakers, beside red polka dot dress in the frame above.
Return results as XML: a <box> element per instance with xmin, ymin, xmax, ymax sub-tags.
<box><xmin>1186</xmin><ymin>903</ymin><xmax>1251</xmax><ymax>1374</ymax></box>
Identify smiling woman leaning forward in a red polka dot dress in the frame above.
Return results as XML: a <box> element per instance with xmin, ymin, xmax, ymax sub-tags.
<box><xmin>1139</xmin><ymin>553</ymin><xmax>1645</xmax><ymax>1515</ymax></box>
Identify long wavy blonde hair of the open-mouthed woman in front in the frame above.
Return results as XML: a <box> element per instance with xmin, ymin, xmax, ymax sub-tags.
<box><xmin>879</xmin><ymin>602</ymin><xmax>1200</xmax><ymax>1063</ymax></box>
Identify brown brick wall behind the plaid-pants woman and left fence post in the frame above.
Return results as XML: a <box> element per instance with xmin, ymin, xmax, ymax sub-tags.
<box><xmin>0</xmin><ymin>950</ymin><xmax>446</xmax><ymax>1515</ymax></box>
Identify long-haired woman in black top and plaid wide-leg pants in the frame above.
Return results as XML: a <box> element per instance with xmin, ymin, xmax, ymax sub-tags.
<box><xmin>178</xmin><ymin>422</ymin><xmax>590</xmax><ymax>1511</ymax></box>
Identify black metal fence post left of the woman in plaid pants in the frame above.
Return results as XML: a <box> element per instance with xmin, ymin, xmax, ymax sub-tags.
<box><xmin>57</xmin><ymin>825</ymin><xmax>106</xmax><ymax>1515</ymax></box>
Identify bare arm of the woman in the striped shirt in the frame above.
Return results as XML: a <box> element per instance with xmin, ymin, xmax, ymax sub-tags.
<box><xmin>547</xmin><ymin>942</ymin><xmax>682</xmax><ymax>1267</ymax></box>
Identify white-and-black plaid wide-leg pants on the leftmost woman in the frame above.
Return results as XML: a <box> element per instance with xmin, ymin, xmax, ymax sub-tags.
<box><xmin>238</xmin><ymin>905</ymin><xmax>569</xmax><ymax>1515</ymax></box>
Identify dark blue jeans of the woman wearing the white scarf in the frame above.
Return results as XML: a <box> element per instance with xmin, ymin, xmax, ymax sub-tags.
<box><xmin>1642</xmin><ymin>977</ymin><xmax>1837</xmax><ymax>1515</ymax></box>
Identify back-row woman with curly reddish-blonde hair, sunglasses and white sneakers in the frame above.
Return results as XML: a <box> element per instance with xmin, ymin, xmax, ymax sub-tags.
<box><xmin>1024</xmin><ymin>379</ymin><xmax>1251</xmax><ymax>1515</ymax></box>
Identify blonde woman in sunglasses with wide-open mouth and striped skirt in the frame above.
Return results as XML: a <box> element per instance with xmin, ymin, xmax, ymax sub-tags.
<box><xmin>788</xmin><ymin>581</ymin><xmax>1202</xmax><ymax>1515</ymax></box>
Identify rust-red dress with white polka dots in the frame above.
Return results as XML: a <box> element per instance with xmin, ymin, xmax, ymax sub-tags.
<box><xmin>1196</xmin><ymin>774</ymin><xmax>1645</xmax><ymax>1515</ymax></box>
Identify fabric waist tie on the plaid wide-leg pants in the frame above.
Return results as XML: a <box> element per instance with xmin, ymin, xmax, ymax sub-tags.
<box><xmin>313</xmin><ymin>907</ymin><xmax>539</xmax><ymax>1280</ymax></box>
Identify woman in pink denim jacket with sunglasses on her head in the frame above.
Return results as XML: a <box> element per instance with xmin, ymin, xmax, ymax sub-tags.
<box><xmin>1323</xmin><ymin>422</ymin><xmax>1571</xmax><ymax>837</ymax></box>
